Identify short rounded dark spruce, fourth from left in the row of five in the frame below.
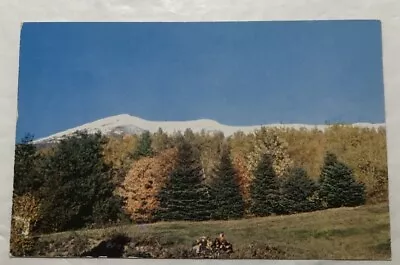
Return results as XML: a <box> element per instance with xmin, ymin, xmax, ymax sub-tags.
<box><xmin>281</xmin><ymin>168</ymin><xmax>319</xmax><ymax>213</ymax></box>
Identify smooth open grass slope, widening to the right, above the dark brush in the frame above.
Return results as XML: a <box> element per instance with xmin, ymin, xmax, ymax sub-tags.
<box><xmin>42</xmin><ymin>201</ymin><xmax>390</xmax><ymax>260</ymax></box>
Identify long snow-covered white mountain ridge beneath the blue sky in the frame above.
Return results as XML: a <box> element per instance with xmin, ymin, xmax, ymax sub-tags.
<box><xmin>35</xmin><ymin>114</ymin><xmax>385</xmax><ymax>143</ymax></box>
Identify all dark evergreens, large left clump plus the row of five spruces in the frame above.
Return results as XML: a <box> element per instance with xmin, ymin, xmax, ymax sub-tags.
<box><xmin>14</xmin><ymin>129</ymin><xmax>365</xmax><ymax>232</ymax></box>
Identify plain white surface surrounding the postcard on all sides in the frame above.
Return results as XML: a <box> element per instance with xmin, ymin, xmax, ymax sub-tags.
<box><xmin>0</xmin><ymin>0</ymin><xmax>400</xmax><ymax>265</ymax></box>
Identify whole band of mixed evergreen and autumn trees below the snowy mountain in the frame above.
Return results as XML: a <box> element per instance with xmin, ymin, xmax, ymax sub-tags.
<box><xmin>10</xmin><ymin>124</ymin><xmax>388</xmax><ymax>256</ymax></box>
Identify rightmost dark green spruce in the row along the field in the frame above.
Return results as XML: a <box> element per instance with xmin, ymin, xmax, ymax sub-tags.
<box><xmin>320</xmin><ymin>154</ymin><xmax>365</xmax><ymax>208</ymax></box>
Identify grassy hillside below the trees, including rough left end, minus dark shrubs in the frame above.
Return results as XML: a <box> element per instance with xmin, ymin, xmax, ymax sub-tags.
<box><xmin>36</xmin><ymin>203</ymin><xmax>391</xmax><ymax>260</ymax></box>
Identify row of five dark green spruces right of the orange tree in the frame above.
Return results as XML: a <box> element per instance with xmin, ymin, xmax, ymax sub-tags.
<box><xmin>146</xmin><ymin>132</ymin><xmax>365</xmax><ymax>221</ymax></box>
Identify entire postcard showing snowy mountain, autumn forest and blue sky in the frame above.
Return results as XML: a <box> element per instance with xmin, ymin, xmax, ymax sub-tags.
<box><xmin>10</xmin><ymin>20</ymin><xmax>391</xmax><ymax>260</ymax></box>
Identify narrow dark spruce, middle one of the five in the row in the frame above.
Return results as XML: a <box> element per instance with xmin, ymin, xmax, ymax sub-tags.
<box><xmin>250</xmin><ymin>154</ymin><xmax>282</xmax><ymax>216</ymax></box>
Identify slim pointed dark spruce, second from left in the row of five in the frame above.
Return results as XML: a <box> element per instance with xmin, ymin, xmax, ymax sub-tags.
<box><xmin>212</xmin><ymin>144</ymin><xmax>244</xmax><ymax>219</ymax></box>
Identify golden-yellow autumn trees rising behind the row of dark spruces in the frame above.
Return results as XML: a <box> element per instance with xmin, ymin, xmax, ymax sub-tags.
<box><xmin>105</xmin><ymin>125</ymin><xmax>388</xmax><ymax>203</ymax></box>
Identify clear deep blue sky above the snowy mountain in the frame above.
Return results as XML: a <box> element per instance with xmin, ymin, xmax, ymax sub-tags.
<box><xmin>17</xmin><ymin>21</ymin><xmax>384</xmax><ymax>139</ymax></box>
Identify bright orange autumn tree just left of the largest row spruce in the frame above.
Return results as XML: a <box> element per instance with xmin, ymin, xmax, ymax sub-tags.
<box><xmin>118</xmin><ymin>148</ymin><xmax>177</xmax><ymax>222</ymax></box>
